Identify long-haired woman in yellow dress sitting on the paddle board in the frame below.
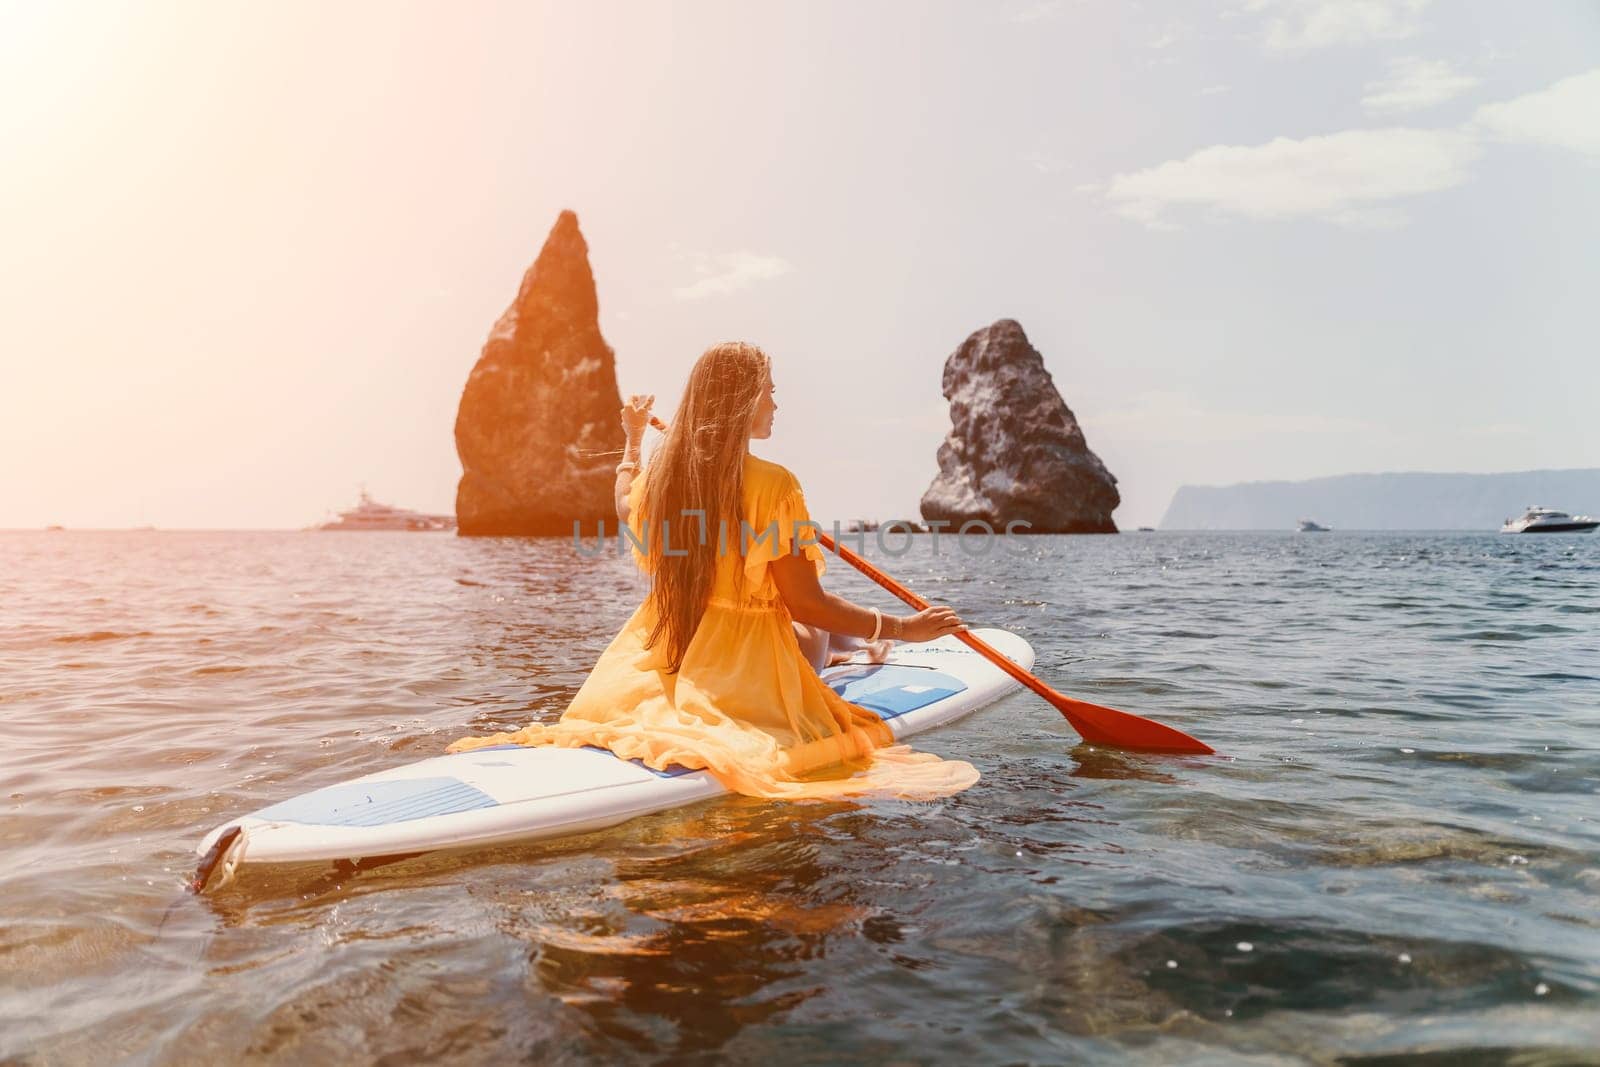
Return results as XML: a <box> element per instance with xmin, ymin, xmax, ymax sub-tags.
<box><xmin>450</xmin><ymin>342</ymin><xmax>978</xmax><ymax>798</ymax></box>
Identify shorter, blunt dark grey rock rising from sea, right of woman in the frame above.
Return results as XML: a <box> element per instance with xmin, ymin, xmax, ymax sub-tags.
<box><xmin>922</xmin><ymin>318</ymin><xmax>1122</xmax><ymax>533</ymax></box>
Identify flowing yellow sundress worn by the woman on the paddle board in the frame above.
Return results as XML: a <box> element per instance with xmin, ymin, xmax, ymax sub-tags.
<box><xmin>450</xmin><ymin>456</ymin><xmax>978</xmax><ymax>800</ymax></box>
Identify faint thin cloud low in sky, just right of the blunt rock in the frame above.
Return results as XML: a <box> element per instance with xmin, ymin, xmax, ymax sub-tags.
<box><xmin>1078</xmin><ymin>390</ymin><xmax>1374</xmax><ymax>445</ymax></box>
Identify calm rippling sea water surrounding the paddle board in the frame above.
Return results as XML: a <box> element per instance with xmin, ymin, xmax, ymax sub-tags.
<box><xmin>0</xmin><ymin>531</ymin><xmax>1600</xmax><ymax>1064</ymax></box>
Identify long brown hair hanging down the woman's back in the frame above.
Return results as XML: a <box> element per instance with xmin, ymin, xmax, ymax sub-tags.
<box><xmin>640</xmin><ymin>341</ymin><xmax>771</xmax><ymax>672</ymax></box>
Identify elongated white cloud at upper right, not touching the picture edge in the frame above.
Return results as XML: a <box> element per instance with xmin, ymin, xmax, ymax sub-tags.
<box><xmin>1106</xmin><ymin>128</ymin><xmax>1480</xmax><ymax>229</ymax></box>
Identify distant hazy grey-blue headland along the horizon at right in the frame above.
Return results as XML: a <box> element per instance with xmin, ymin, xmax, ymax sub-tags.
<box><xmin>1162</xmin><ymin>469</ymin><xmax>1600</xmax><ymax>530</ymax></box>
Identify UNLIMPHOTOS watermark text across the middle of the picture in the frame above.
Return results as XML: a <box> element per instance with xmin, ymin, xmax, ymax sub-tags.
<box><xmin>573</xmin><ymin>507</ymin><xmax>1032</xmax><ymax>557</ymax></box>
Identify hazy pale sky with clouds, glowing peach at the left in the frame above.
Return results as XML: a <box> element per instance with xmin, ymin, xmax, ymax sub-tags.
<box><xmin>0</xmin><ymin>0</ymin><xmax>1600</xmax><ymax>528</ymax></box>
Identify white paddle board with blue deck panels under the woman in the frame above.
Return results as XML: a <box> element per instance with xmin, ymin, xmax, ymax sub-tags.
<box><xmin>194</xmin><ymin>629</ymin><xmax>1034</xmax><ymax>889</ymax></box>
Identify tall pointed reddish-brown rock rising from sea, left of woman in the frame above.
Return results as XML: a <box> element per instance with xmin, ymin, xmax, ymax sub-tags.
<box><xmin>456</xmin><ymin>211</ymin><xmax>622</xmax><ymax>536</ymax></box>
